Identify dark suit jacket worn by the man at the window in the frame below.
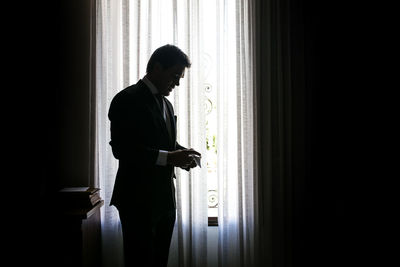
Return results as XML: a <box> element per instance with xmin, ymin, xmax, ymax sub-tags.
<box><xmin>108</xmin><ymin>80</ymin><xmax>183</xmax><ymax>224</ymax></box>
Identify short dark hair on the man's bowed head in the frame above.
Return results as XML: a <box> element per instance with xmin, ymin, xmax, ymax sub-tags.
<box><xmin>146</xmin><ymin>44</ymin><xmax>191</xmax><ymax>73</ymax></box>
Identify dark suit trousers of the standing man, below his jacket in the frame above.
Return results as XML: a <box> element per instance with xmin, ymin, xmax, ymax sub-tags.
<box><xmin>118</xmin><ymin>208</ymin><xmax>176</xmax><ymax>267</ymax></box>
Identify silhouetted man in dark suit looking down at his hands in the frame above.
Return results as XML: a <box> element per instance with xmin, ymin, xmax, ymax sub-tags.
<box><xmin>108</xmin><ymin>45</ymin><xmax>200</xmax><ymax>266</ymax></box>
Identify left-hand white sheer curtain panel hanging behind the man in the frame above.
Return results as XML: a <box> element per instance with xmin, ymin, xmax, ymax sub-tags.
<box><xmin>96</xmin><ymin>0</ymin><xmax>208</xmax><ymax>266</ymax></box>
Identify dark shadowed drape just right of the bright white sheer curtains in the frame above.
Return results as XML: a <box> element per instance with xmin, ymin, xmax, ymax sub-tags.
<box><xmin>253</xmin><ymin>0</ymin><xmax>293</xmax><ymax>266</ymax></box>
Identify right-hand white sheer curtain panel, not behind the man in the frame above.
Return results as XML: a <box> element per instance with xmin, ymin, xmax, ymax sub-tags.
<box><xmin>217</xmin><ymin>0</ymin><xmax>255</xmax><ymax>267</ymax></box>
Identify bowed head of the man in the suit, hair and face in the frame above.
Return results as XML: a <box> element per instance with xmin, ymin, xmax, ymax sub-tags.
<box><xmin>146</xmin><ymin>45</ymin><xmax>191</xmax><ymax>96</ymax></box>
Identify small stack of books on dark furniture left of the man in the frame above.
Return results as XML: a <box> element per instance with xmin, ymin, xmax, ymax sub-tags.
<box><xmin>58</xmin><ymin>187</ymin><xmax>101</xmax><ymax>209</ymax></box>
